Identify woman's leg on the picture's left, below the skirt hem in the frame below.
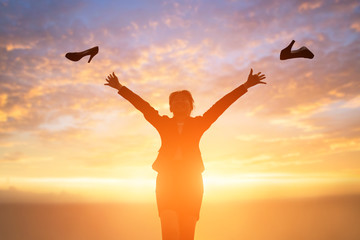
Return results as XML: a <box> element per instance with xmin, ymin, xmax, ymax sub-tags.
<box><xmin>160</xmin><ymin>210</ymin><xmax>180</xmax><ymax>240</ymax></box>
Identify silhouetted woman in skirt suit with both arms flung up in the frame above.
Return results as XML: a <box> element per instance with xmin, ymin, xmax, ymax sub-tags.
<box><xmin>105</xmin><ymin>69</ymin><xmax>265</xmax><ymax>240</ymax></box>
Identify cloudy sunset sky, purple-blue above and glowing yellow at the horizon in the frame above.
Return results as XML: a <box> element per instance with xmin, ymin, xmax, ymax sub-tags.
<box><xmin>0</xmin><ymin>0</ymin><xmax>360</xmax><ymax>202</ymax></box>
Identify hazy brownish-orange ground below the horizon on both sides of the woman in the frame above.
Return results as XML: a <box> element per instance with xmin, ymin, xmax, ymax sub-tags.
<box><xmin>0</xmin><ymin>195</ymin><xmax>360</xmax><ymax>240</ymax></box>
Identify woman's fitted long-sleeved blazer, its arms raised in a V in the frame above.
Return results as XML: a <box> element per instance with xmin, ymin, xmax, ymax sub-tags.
<box><xmin>118</xmin><ymin>85</ymin><xmax>247</xmax><ymax>174</ymax></box>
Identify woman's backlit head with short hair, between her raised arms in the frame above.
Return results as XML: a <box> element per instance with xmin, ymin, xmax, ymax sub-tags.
<box><xmin>169</xmin><ymin>90</ymin><xmax>194</xmax><ymax>116</ymax></box>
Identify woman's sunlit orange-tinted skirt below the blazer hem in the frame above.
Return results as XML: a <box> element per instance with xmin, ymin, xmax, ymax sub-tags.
<box><xmin>156</xmin><ymin>173</ymin><xmax>204</xmax><ymax>220</ymax></box>
